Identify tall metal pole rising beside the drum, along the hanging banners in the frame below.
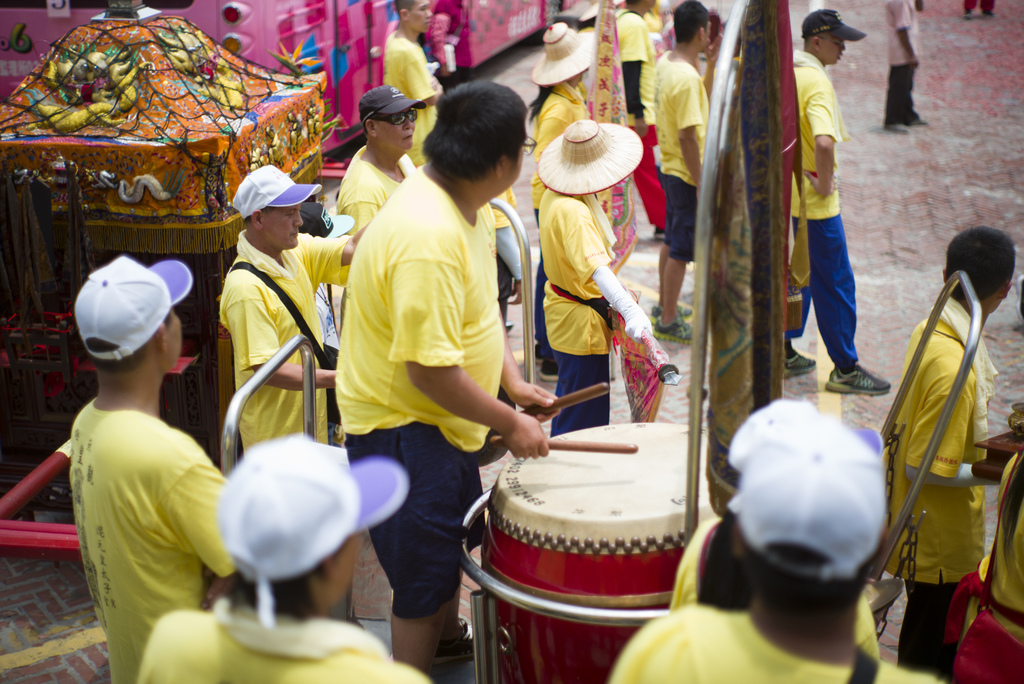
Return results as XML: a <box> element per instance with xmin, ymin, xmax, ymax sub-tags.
<box><xmin>686</xmin><ymin>0</ymin><xmax>750</xmax><ymax>543</ymax></box>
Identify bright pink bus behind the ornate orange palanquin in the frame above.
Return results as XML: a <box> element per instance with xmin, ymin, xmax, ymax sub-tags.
<box><xmin>0</xmin><ymin>0</ymin><xmax>577</xmax><ymax>151</ymax></box>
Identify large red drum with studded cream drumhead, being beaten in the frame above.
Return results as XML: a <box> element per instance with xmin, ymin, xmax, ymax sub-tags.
<box><xmin>483</xmin><ymin>423</ymin><xmax>714</xmax><ymax>684</ymax></box>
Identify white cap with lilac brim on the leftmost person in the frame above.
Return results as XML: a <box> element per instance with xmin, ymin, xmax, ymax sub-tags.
<box><xmin>75</xmin><ymin>256</ymin><xmax>193</xmax><ymax>359</ymax></box>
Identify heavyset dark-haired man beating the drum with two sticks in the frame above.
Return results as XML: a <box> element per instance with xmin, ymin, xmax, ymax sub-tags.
<box><xmin>338</xmin><ymin>81</ymin><xmax>555</xmax><ymax>672</ymax></box>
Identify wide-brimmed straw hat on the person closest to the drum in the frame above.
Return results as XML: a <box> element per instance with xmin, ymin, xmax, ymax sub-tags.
<box><xmin>537</xmin><ymin>119</ymin><xmax>643</xmax><ymax>195</ymax></box>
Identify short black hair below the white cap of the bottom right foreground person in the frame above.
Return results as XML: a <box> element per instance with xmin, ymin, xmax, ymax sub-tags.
<box><xmin>742</xmin><ymin>543</ymin><xmax>870</xmax><ymax>617</ymax></box>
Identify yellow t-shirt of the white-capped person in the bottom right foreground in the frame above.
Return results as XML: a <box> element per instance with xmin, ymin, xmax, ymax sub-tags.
<box><xmin>608</xmin><ymin>606</ymin><xmax>939</xmax><ymax>684</ymax></box>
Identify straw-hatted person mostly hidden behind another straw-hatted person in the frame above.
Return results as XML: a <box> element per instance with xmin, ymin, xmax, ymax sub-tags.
<box><xmin>529</xmin><ymin>21</ymin><xmax>596</xmax><ymax>382</ymax></box>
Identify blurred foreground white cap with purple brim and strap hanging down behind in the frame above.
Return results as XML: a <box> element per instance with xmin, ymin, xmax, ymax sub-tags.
<box><xmin>217</xmin><ymin>435</ymin><xmax>409</xmax><ymax>628</ymax></box>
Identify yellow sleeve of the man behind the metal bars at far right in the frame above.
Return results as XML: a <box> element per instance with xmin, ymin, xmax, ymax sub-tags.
<box><xmin>903</xmin><ymin>352</ymin><xmax>975</xmax><ymax>477</ymax></box>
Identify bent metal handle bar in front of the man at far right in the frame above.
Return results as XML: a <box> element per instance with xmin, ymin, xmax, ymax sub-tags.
<box><xmin>871</xmin><ymin>270</ymin><xmax>981</xmax><ymax>580</ymax></box>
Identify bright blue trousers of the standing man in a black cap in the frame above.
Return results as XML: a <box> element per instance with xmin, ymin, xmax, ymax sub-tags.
<box><xmin>785</xmin><ymin>216</ymin><xmax>857</xmax><ymax>369</ymax></box>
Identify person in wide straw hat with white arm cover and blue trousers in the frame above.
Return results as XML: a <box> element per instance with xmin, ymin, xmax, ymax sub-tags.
<box><xmin>538</xmin><ymin>119</ymin><xmax>651</xmax><ymax>435</ymax></box>
